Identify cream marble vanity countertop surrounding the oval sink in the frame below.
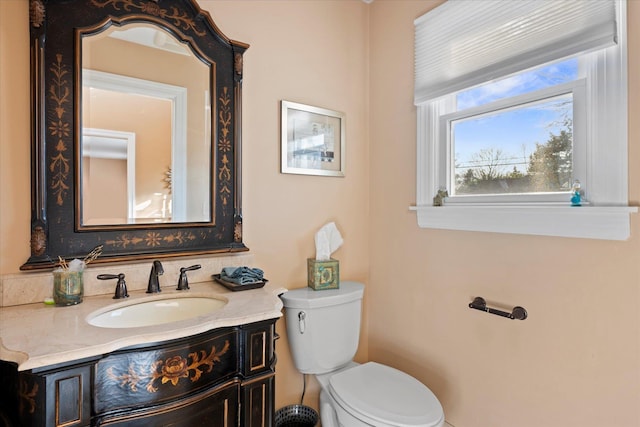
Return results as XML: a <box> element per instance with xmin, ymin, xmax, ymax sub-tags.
<box><xmin>0</xmin><ymin>281</ymin><xmax>286</xmax><ymax>371</ymax></box>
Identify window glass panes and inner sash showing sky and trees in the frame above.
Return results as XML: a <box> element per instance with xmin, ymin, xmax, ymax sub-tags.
<box><xmin>438</xmin><ymin>59</ymin><xmax>584</xmax><ymax>203</ymax></box>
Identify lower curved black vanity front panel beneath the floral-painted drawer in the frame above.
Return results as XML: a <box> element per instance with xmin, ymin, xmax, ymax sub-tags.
<box><xmin>95</xmin><ymin>381</ymin><xmax>241</xmax><ymax>427</ymax></box>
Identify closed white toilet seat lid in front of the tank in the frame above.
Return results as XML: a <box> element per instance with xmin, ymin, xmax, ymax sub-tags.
<box><xmin>329</xmin><ymin>362</ymin><xmax>444</xmax><ymax>427</ymax></box>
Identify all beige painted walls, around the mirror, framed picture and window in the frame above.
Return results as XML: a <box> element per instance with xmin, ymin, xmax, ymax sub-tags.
<box><xmin>0</xmin><ymin>0</ymin><xmax>640</xmax><ymax>427</ymax></box>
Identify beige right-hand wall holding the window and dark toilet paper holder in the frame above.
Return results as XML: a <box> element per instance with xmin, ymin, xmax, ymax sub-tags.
<box><xmin>368</xmin><ymin>0</ymin><xmax>640</xmax><ymax>427</ymax></box>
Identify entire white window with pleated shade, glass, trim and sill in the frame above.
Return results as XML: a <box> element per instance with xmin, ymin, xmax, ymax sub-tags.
<box><xmin>413</xmin><ymin>0</ymin><xmax>636</xmax><ymax>239</ymax></box>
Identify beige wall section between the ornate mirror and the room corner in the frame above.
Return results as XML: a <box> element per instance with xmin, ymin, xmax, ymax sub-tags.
<box><xmin>198</xmin><ymin>0</ymin><xmax>370</xmax><ymax>408</ymax></box>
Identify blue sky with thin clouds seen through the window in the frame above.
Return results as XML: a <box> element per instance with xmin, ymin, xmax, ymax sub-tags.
<box><xmin>455</xmin><ymin>59</ymin><xmax>578</xmax><ymax>172</ymax></box>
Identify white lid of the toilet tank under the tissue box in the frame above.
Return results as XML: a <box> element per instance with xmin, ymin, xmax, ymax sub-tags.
<box><xmin>280</xmin><ymin>282</ymin><xmax>364</xmax><ymax>308</ymax></box>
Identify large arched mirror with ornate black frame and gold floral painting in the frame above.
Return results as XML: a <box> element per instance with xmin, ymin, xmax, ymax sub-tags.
<box><xmin>21</xmin><ymin>0</ymin><xmax>248</xmax><ymax>270</ymax></box>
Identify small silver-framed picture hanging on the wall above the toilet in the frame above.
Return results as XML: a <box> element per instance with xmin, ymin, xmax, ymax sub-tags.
<box><xmin>281</xmin><ymin>100</ymin><xmax>345</xmax><ymax>176</ymax></box>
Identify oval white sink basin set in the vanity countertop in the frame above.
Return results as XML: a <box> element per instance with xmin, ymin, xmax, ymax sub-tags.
<box><xmin>87</xmin><ymin>297</ymin><xmax>227</xmax><ymax>328</ymax></box>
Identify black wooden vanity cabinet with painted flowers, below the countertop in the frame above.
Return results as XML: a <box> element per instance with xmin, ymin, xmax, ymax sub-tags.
<box><xmin>0</xmin><ymin>319</ymin><xmax>276</xmax><ymax>427</ymax></box>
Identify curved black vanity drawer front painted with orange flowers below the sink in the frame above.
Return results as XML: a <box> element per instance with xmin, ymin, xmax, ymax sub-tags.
<box><xmin>94</xmin><ymin>328</ymin><xmax>240</xmax><ymax>414</ymax></box>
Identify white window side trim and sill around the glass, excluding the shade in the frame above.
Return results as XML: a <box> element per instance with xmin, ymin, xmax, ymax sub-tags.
<box><xmin>410</xmin><ymin>1</ymin><xmax>637</xmax><ymax>240</ymax></box>
